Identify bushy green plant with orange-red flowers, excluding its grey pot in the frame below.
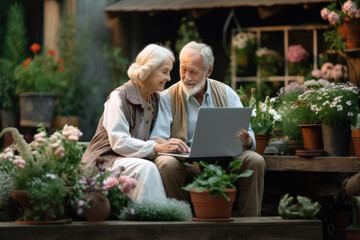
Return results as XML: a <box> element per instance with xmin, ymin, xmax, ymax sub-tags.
<box><xmin>15</xmin><ymin>43</ymin><xmax>64</xmax><ymax>94</ymax></box>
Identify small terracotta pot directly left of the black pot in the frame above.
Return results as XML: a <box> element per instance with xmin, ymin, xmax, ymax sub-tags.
<box><xmin>299</xmin><ymin>124</ymin><xmax>324</xmax><ymax>150</ymax></box>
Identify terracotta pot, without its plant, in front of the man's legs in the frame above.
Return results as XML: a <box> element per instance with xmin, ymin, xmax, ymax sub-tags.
<box><xmin>190</xmin><ymin>189</ymin><xmax>236</xmax><ymax>222</ymax></box>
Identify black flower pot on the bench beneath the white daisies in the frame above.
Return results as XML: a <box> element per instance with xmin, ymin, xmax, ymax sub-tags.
<box><xmin>321</xmin><ymin>124</ymin><xmax>351</xmax><ymax>156</ymax></box>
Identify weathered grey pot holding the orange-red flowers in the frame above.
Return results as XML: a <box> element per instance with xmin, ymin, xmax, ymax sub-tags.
<box><xmin>20</xmin><ymin>92</ymin><xmax>55</xmax><ymax>128</ymax></box>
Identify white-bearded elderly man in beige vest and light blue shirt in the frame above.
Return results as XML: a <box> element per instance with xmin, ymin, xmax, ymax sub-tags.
<box><xmin>150</xmin><ymin>42</ymin><xmax>265</xmax><ymax>216</ymax></box>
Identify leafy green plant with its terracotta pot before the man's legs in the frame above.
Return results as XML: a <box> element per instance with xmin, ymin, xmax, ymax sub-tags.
<box><xmin>183</xmin><ymin>159</ymin><xmax>253</xmax><ymax>221</ymax></box>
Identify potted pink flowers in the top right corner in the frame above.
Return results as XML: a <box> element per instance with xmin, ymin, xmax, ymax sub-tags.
<box><xmin>321</xmin><ymin>0</ymin><xmax>360</xmax><ymax>50</ymax></box>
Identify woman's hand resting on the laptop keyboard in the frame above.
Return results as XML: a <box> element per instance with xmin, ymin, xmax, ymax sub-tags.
<box><xmin>154</xmin><ymin>138</ymin><xmax>190</xmax><ymax>153</ymax></box>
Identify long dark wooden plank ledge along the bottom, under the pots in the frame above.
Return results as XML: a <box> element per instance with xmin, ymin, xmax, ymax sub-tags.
<box><xmin>0</xmin><ymin>217</ymin><xmax>322</xmax><ymax>240</ymax></box>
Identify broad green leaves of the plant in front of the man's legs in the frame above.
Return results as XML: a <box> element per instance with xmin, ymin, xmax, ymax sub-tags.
<box><xmin>183</xmin><ymin>158</ymin><xmax>253</xmax><ymax>201</ymax></box>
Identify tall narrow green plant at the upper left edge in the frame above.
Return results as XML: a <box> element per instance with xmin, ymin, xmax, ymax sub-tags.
<box><xmin>0</xmin><ymin>3</ymin><xmax>27</xmax><ymax>109</ymax></box>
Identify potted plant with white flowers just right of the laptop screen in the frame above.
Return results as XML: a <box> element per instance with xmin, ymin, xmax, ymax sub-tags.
<box><xmin>238</xmin><ymin>88</ymin><xmax>281</xmax><ymax>155</ymax></box>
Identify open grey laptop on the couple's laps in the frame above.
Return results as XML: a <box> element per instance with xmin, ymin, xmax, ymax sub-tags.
<box><xmin>159</xmin><ymin>108</ymin><xmax>252</xmax><ymax>159</ymax></box>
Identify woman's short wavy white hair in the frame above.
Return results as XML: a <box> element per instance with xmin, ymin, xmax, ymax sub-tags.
<box><xmin>127</xmin><ymin>44</ymin><xmax>175</xmax><ymax>82</ymax></box>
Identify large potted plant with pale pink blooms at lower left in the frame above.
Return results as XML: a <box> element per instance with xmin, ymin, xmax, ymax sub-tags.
<box><xmin>0</xmin><ymin>126</ymin><xmax>83</xmax><ymax>224</ymax></box>
